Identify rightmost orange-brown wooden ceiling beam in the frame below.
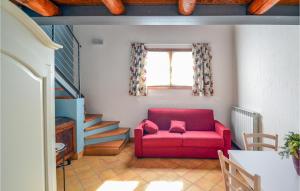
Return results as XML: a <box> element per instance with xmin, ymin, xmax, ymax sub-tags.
<box><xmin>248</xmin><ymin>0</ymin><xmax>280</xmax><ymax>15</ymax></box>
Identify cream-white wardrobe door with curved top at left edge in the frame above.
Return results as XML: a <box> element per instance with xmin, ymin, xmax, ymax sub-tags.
<box><xmin>1</xmin><ymin>53</ymin><xmax>46</xmax><ymax>191</ymax></box>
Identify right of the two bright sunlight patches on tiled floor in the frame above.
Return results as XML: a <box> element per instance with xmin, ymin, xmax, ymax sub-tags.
<box><xmin>146</xmin><ymin>181</ymin><xmax>183</xmax><ymax>191</ymax></box>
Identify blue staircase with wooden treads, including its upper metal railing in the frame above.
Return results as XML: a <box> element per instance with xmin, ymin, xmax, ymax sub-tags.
<box><xmin>41</xmin><ymin>25</ymin><xmax>129</xmax><ymax>156</ymax></box>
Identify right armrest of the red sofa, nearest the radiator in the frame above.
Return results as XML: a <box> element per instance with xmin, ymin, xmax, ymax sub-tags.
<box><xmin>215</xmin><ymin>120</ymin><xmax>231</xmax><ymax>157</ymax></box>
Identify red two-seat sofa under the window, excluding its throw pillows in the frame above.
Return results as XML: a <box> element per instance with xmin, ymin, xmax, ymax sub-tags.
<box><xmin>134</xmin><ymin>108</ymin><xmax>231</xmax><ymax>158</ymax></box>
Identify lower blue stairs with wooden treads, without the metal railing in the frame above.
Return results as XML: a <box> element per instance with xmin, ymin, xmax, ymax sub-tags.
<box><xmin>55</xmin><ymin>87</ymin><xmax>130</xmax><ymax>156</ymax></box>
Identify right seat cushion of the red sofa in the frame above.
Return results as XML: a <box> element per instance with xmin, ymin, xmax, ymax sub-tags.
<box><xmin>182</xmin><ymin>131</ymin><xmax>224</xmax><ymax>148</ymax></box>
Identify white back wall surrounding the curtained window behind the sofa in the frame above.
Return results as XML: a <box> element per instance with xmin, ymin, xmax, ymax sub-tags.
<box><xmin>74</xmin><ymin>25</ymin><xmax>235</xmax><ymax>135</ymax></box>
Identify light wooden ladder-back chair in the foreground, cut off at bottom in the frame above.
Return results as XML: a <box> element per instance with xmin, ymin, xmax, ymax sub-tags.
<box><xmin>218</xmin><ymin>150</ymin><xmax>261</xmax><ymax>191</ymax></box>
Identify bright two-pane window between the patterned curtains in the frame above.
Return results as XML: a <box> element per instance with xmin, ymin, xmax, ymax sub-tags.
<box><xmin>146</xmin><ymin>49</ymin><xmax>193</xmax><ymax>88</ymax></box>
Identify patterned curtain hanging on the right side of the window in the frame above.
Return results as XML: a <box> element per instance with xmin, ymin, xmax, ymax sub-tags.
<box><xmin>192</xmin><ymin>43</ymin><xmax>214</xmax><ymax>96</ymax></box>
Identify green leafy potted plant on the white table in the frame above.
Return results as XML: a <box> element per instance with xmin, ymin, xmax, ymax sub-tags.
<box><xmin>279</xmin><ymin>132</ymin><xmax>300</xmax><ymax>176</ymax></box>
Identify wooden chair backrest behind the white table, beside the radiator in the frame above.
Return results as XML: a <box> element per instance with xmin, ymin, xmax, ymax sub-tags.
<box><xmin>243</xmin><ymin>133</ymin><xmax>278</xmax><ymax>151</ymax></box>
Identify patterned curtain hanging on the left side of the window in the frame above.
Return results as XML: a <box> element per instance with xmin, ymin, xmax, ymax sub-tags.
<box><xmin>129</xmin><ymin>43</ymin><xmax>147</xmax><ymax>96</ymax></box>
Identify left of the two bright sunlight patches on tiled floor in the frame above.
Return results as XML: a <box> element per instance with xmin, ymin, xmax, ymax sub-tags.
<box><xmin>96</xmin><ymin>181</ymin><xmax>139</xmax><ymax>191</ymax></box>
